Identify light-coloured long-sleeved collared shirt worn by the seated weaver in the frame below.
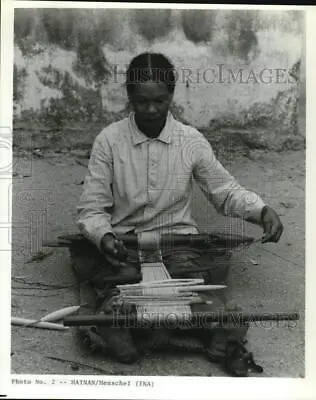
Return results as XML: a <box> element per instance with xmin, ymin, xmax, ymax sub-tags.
<box><xmin>77</xmin><ymin>113</ymin><xmax>265</xmax><ymax>248</ymax></box>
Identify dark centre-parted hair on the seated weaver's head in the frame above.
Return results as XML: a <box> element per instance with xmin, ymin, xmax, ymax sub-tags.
<box><xmin>126</xmin><ymin>53</ymin><xmax>176</xmax><ymax>96</ymax></box>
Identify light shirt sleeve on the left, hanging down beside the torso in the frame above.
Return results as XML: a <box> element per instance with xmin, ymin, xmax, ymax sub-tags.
<box><xmin>77</xmin><ymin>133</ymin><xmax>113</xmax><ymax>249</ymax></box>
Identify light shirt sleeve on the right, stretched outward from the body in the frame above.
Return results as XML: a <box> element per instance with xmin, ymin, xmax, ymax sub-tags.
<box><xmin>193</xmin><ymin>137</ymin><xmax>265</xmax><ymax>223</ymax></box>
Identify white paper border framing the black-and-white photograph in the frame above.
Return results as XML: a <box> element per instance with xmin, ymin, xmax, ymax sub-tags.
<box><xmin>0</xmin><ymin>0</ymin><xmax>316</xmax><ymax>399</ymax></box>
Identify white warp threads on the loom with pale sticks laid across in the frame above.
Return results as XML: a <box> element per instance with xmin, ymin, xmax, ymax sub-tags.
<box><xmin>117</xmin><ymin>233</ymin><xmax>225</xmax><ymax>320</ymax></box>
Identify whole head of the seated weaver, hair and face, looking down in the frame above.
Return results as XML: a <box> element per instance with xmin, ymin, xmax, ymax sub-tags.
<box><xmin>126</xmin><ymin>53</ymin><xmax>176</xmax><ymax>136</ymax></box>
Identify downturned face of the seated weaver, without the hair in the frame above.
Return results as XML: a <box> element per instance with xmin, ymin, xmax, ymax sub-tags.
<box><xmin>130</xmin><ymin>81</ymin><xmax>172</xmax><ymax>131</ymax></box>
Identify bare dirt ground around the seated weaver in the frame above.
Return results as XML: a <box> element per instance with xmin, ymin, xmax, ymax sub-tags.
<box><xmin>11</xmin><ymin>150</ymin><xmax>305</xmax><ymax>377</ymax></box>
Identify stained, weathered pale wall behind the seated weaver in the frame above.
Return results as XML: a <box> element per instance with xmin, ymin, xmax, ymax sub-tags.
<box><xmin>15</xmin><ymin>10</ymin><xmax>305</xmax><ymax>150</ymax></box>
